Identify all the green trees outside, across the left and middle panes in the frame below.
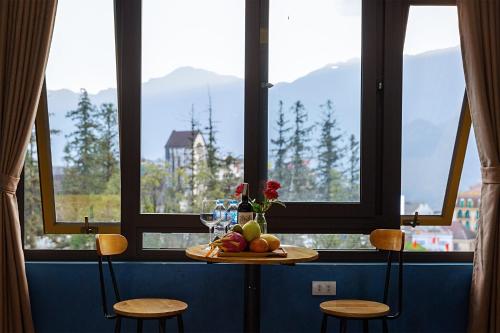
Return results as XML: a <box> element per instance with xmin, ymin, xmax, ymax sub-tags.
<box><xmin>25</xmin><ymin>89</ymin><xmax>359</xmax><ymax>248</ymax></box>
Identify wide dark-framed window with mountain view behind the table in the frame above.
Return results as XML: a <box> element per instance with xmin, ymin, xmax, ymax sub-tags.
<box><xmin>25</xmin><ymin>0</ymin><xmax>478</xmax><ymax>259</ymax></box>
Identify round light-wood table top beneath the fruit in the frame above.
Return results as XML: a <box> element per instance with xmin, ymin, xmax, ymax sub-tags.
<box><xmin>186</xmin><ymin>244</ymin><xmax>318</xmax><ymax>265</ymax></box>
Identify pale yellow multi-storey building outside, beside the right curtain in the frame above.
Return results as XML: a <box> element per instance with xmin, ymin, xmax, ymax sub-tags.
<box><xmin>453</xmin><ymin>184</ymin><xmax>481</xmax><ymax>232</ymax></box>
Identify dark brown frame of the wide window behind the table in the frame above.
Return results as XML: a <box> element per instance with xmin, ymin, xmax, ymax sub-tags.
<box><xmin>19</xmin><ymin>0</ymin><xmax>472</xmax><ymax>261</ymax></box>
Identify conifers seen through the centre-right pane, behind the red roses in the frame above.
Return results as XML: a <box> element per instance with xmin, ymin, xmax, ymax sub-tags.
<box><xmin>269</xmin><ymin>99</ymin><xmax>360</xmax><ymax>202</ymax></box>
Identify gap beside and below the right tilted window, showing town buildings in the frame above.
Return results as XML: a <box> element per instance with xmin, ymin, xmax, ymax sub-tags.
<box><xmin>403</xmin><ymin>130</ymin><xmax>481</xmax><ymax>251</ymax></box>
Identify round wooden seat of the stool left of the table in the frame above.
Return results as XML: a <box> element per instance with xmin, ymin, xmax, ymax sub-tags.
<box><xmin>113</xmin><ymin>298</ymin><xmax>188</xmax><ymax>318</ymax></box>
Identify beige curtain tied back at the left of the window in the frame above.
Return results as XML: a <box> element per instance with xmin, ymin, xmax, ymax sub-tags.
<box><xmin>0</xmin><ymin>0</ymin><xmax>57</xmax><ymax>332</ymax></box>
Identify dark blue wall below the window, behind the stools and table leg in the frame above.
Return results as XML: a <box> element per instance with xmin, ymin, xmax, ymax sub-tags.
<box><xmin>26</xmin><ymin>262</ymin><xmax>472</xmax><ymax>333</ymax></box>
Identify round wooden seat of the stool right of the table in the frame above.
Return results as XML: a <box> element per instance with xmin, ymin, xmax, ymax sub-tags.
<box><xmin>319</xmin><ymin>299</ymin><xmax>390</xmax><ymax>319</ymax></box>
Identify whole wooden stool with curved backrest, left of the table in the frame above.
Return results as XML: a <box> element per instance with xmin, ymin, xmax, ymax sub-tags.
<box><xmin>96</xmin><ymin>234</ymin><xmax>188</xmax><ymax>332</ymax></box>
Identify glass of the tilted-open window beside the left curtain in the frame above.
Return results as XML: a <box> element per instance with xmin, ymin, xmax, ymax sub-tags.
<box><xmin>46</xmin><ymin>0</ymin><xmax>120</xmax><ymax>223</ymax></box>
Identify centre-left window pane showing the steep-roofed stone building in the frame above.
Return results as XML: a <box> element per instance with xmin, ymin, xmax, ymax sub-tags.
<box><xmin>141</xmin><ymin>0</ymin><xmax>245</xmax><ymax>213</ymax></box>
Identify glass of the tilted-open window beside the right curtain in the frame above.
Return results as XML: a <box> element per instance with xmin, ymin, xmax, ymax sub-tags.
<box><xmin>401</xmin><ymin>6</ymin><xmax>465</xmax><ymax>215</ymax></box>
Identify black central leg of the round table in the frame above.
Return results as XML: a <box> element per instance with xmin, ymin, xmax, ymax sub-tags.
<box><xmin>243</xmin><ymin>265</ymin><xmax>260</xmax><ymax>333</ymax></box>
